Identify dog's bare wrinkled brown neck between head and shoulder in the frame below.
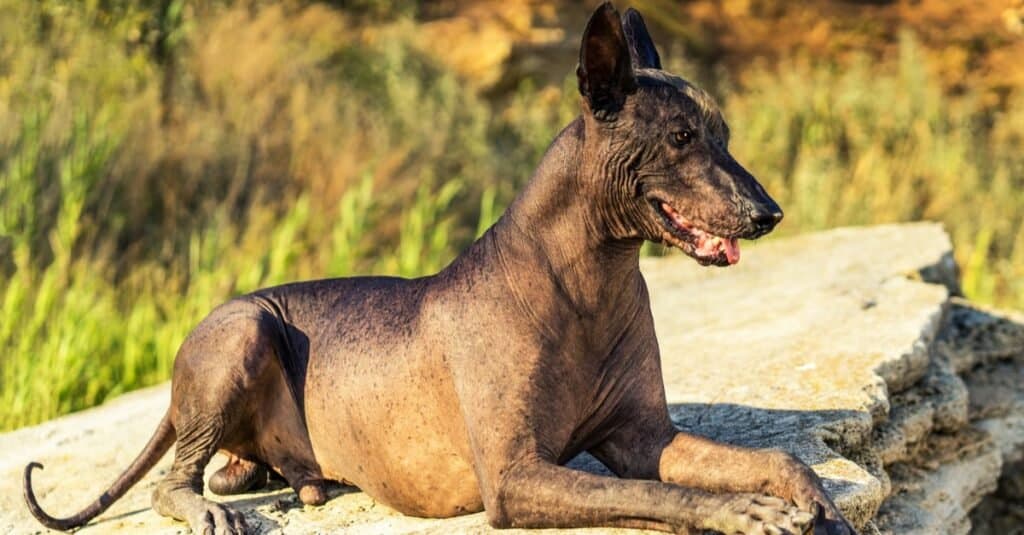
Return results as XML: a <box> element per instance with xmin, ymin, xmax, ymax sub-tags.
<box><xmin>492</xmin><ymin>118</ymin><xmax>642</xmax><ymax>314</ymax></box>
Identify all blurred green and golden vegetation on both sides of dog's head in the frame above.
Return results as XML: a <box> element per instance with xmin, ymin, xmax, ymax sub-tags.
<box><xmin>0</xmin><ymin>0</ymin><xmax>1024</xmax><ymax>429</ymax></box>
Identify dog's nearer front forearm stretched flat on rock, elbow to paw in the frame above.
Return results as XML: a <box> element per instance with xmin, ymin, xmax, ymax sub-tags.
<box><xmin>484</xmin><ymin>453</ymin><xmax>813</xmax><ymax>534</ymax></box>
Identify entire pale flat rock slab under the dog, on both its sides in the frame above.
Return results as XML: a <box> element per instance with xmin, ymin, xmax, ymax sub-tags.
<box><xmin>0</xmin><ymin>223</ymin><xmax>955</xmax><ymax>534</ymax></box>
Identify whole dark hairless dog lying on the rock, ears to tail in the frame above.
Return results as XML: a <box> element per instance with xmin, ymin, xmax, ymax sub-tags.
<box><xmin>25</xmin><ymin>4</ymin><xmax>853</xmax><ymax>534</ymax></box>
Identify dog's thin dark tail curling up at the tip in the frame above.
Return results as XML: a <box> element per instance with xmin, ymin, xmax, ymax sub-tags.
<box><xmin>24</xmin><ymin>407</ymin><xmax>174</xmax><ymax>531</ymax></box>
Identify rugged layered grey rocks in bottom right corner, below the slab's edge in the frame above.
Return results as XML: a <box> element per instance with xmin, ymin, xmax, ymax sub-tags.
<box><xmin>876</xmin><ymin>298</ymin><xmax>1024</xmax><ymax>535</ymax></box>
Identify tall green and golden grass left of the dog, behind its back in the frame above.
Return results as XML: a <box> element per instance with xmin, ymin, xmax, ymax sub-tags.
<box><xmin>0</xmin><ymin>0</ymin><xmax>557</xmax><ymax>429</ymax></box>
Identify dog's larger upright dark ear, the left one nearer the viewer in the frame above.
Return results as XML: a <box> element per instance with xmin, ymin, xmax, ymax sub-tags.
<box><xmin>577</xmin><ymin>2</ymin><xmax>637</xmax><ymax>121</ymax></box>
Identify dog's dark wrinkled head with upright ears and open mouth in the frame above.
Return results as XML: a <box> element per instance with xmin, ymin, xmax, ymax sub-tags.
<box><xmin>577</xmin><ymin>3</ymin><xmax>782</xmax><ymax>265</ymax></box>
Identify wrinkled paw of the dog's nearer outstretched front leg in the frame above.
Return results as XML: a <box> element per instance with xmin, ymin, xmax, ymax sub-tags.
<box><xmin>702</xmin><ymin>494</ymin><xmax>814</xmax><ymax>535</ymax></box>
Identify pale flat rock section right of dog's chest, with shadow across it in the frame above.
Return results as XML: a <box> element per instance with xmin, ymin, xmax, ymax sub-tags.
<box><xmin>643</xmin><ymin>224</ymin><xmax>951</xmax><ymax>525</ymax></box>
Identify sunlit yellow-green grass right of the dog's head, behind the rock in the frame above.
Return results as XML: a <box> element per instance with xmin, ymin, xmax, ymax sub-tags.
<box><xmin>727</xmin><ymin>34</ymin><xmax>1024</xmax><ymax>308</ymax></box>
